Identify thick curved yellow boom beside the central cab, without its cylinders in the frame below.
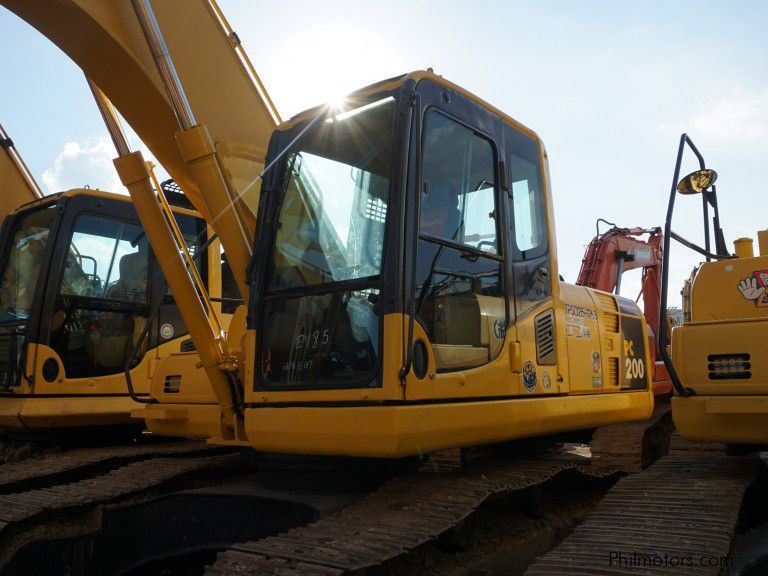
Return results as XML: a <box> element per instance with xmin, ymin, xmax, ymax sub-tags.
<box><xmin>0</xmin><ymin>0</ymin><xmax>280</xmax><ymax>296</ymax></box>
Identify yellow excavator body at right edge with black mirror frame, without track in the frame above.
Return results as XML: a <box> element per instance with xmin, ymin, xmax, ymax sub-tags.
<box><xmin>660</xmin><ymin>134</ymin><xmax>768</xmax><ymax>446</ymax></box>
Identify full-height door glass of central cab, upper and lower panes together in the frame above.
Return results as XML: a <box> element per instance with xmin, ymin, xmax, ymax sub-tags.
<box><xmin>416</xmin><ymin>113</ymin><xmax>507</xmax><ymax>372</ymax></box>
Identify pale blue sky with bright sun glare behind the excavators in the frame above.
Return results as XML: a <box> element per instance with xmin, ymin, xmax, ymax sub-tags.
<box><xmin>0</xmin><ymin>0</ymin><xmax>768</xmax><ymax>306</ymax></box>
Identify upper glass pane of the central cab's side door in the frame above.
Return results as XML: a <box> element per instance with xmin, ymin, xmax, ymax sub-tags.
<box><xmin>420</xmin><ymin>113</ymin><xmax>498</xmax><ymax>254</ymax></box>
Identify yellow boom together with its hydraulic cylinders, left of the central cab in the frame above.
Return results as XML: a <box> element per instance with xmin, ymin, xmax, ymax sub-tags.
<box><xmin>3</xmin><ymin>0</ymin><xmax>280</xmax><ymax>437</ymax></box>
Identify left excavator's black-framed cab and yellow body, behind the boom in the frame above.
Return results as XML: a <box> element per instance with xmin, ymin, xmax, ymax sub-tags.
<box><xmin>0</xmin><ymin>190</ymin><xmax>225</xmax><ymax>429</ymax></box>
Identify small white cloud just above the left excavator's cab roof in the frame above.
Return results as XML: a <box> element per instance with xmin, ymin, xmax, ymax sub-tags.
<box><xmin>41</xmin><ymin>137</ymin><xmax>125</xmax><ymax>194</ymax></box>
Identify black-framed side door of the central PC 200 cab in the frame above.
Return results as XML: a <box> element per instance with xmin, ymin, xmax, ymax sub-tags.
<box><xmin>405</xmin><ymin>80</ymin><xmax>510</xmax><ymax>399</ymax></box>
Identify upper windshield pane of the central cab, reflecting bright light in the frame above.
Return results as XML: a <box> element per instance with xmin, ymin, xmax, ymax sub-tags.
<box><xmin>269</xmin><ymin>98</ymin><xmax>396</xmax><ymax>290</ymax></box>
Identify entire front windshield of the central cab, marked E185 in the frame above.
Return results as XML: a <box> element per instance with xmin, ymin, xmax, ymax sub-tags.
<box><xmin>261</xmin><ymin>97</ymin><xmax>397</xmax><ymax>386</ymax></box>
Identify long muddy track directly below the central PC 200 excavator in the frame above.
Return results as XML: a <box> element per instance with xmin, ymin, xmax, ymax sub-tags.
<box><xmin>205</xmin><ymin>457</ymin><xmax>621</xmax><ymax>576</ymax></box>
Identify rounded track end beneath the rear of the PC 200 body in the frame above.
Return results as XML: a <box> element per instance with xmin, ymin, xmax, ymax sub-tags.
<box><xmin>590</xmin><ymin>403</ymin><xmax>674</xmax><ymax>472</ymax></box>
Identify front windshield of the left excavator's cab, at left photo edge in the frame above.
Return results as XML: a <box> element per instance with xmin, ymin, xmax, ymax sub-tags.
<box><xmin>0</xmin><ymin>206</ymin><xmax>58</xmax><ymax>322</ymax></box>
